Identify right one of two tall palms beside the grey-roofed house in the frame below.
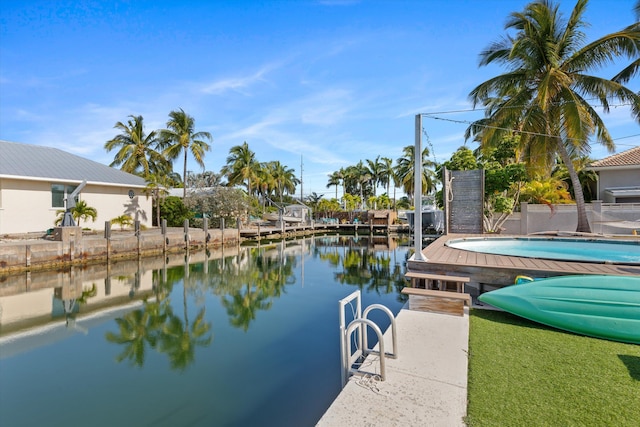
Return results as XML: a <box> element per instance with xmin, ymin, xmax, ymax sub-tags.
<box><xmin>160</xmin><ymin>108</ymin><xmax>212</xmax><ymax>197</ymax></box>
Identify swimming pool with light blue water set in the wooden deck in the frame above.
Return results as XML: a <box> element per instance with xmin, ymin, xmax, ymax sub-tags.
<box><xmin>446</xmin><ymin>237</ymin><xmax>640</xmax><ymax>264</ymax></box>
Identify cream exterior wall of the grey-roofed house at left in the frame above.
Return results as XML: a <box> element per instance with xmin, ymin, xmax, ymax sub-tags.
<box><xmin>0</xmin><ymin>178</ymin><xmax>153</xmax><ymax>235</ymax></box>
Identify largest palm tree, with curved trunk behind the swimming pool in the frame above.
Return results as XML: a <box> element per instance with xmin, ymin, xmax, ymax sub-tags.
<box><xmin>467</xmin><ymin>0</ymin><xmax>640</xmax><ymax>232</ymax></box>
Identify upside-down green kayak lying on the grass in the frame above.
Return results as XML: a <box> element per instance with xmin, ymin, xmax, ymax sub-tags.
<box><xmin>478</xmin><ymin>275</ymin><xmax>640</xmax><ymax>344</ymax></box>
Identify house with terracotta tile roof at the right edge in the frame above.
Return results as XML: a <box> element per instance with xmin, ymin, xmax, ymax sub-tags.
<box><xmin>588</xmin><ymin>146</ymin><xmax>640</xmax><ymax>203</ymax></box>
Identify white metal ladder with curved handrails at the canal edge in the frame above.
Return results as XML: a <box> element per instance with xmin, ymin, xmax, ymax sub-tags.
<box><xmin>338</xmin><ymin>290</ymin><xmax>398</xmax><ymax>388</ymax></box>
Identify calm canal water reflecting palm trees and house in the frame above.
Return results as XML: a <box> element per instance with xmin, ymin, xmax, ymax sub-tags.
<box><xmin>0</xmin><ymin>236</ymin><xmax>409</xmax><ymax>427</ymax></box>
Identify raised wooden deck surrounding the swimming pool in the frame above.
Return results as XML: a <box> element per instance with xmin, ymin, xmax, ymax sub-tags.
<box><xmin>407</xmin><ymin>234</ymin><xmax>640</xmax><ymax>292</ymax></box>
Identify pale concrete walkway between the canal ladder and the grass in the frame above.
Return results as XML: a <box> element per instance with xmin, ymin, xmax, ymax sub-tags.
<box><xmin>317</xmin><ymin>305</ymin><xmax>469</xmax><ymax>427</ymax></box>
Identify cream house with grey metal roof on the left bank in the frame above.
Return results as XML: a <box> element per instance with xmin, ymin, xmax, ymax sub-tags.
<box><xmin>0</xmin><ymin>141</ymin><xmax>153</xmax><ymax>235</ymax></box>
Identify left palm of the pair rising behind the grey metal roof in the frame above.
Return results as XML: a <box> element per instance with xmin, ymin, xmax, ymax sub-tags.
<box><xmin>104</xmin><ymin>116</ymin><xmax>167</xmax><ymax>178</ymax></box>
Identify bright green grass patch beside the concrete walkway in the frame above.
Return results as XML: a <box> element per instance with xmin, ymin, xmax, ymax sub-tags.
<box><xmin>467</xmin><ymin>310</ymin><xmax>640</xmax><ymax>426</ymax></box>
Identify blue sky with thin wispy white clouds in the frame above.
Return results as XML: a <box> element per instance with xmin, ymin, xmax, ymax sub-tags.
<box><xmin>0</xmin><ymin>0</ymin><xmax>640</xmax><ymax>197</ymax></box>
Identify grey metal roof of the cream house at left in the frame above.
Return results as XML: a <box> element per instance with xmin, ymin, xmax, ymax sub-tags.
<box><xmin>0</xmin><ymin>140</ymin><xmax>146</xmax><ymax>187</ymax></box>
